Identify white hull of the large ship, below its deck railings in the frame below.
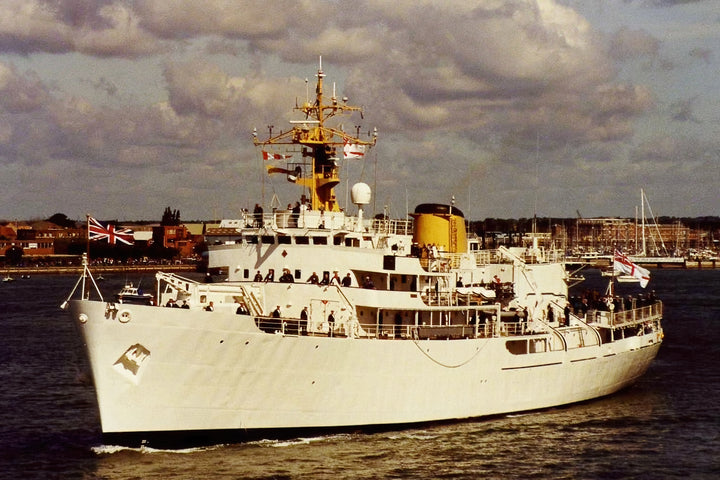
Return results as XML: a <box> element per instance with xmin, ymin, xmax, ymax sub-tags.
<box><xmin>70</xmin><ymin>300</ymin><xmax>661</xmax><ymax>444</ymax></box>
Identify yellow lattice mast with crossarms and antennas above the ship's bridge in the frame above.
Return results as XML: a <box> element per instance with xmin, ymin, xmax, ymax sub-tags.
<box><xmin>253</xmin><ymin>57</ymin><xmax>377</xmax><ymax>212</ymax></box>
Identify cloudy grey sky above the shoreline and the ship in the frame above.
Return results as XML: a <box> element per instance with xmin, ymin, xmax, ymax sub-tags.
<box><xmin>0</xmin><ymin>0</ymin><xmax>720</xmax><ymax>221</ymax></box>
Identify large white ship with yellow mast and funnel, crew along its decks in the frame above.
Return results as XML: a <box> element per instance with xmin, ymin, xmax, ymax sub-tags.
<box><xmin>69</xmin><ymin>62</ymin><xmax>663</xmax><ymax>445</ymax></box>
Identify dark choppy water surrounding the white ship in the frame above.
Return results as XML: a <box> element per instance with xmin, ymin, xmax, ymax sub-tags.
<box><xmin>0</xmin><ymin>270</ymin><xmax>720</xmax><ymax>479</ymax></box>
